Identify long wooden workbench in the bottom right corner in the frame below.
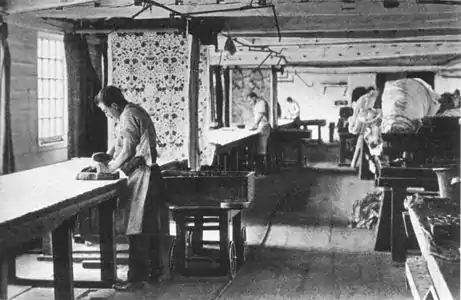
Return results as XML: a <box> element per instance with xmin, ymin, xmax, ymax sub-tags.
<box><xmin>407</xmin><ymin>199</ymin><xmax>460</xmax><ymax>300</ymax></box>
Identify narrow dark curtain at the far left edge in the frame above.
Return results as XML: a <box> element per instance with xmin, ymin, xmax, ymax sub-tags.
<box><xmin>0</xmin><ymin>23</ymin><xmax>14</xmax><ymax>174</ymax></box>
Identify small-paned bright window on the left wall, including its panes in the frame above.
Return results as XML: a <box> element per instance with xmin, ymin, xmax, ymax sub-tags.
<box><xmin>37</xmin><ymin>32</ymin><xmax>67</xmax><ymax>146</ymax></box>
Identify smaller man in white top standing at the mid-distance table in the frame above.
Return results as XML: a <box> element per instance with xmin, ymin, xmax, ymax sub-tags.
<box><xmin>248</xmin><ymin>92</ymin><xmax>271</xmax><ymax>174</ymax></box>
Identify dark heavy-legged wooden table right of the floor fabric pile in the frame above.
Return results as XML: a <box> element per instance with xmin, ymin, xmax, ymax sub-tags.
<box><xmin>375</xmin><ymin>167</ymin><xmax>438</xmax><ymax>262</ymax></box>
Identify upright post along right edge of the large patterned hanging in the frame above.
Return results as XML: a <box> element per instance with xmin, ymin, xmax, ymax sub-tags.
<box><xmin>189</xmin><ymin>35</ymin><xmax>200</xmax><ymax>170</ymax></box>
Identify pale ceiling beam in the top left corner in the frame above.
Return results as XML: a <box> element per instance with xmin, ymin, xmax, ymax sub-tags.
<box><xmin>6</xmin><ymin>0</ymin><xmax>99</xmax><ymax>14</ymax></box>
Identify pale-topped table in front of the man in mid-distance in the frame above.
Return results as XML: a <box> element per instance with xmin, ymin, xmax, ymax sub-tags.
<box><xmin>208</xmin><ymin>127</ymin><xmax>258</xmax><ymax>171</ymax></box>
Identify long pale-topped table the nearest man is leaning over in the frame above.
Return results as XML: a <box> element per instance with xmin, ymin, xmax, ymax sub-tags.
<box><xmin>0</xmin><ymin>158</ymin><xmax>126</xmax><ymax>300</ymax></box>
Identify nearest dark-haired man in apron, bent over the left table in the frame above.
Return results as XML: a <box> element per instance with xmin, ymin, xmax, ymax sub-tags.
<box><xmin>95</xmin><ymin>86</ymin><xmax>170</xmax><ymax>291</ymax></box>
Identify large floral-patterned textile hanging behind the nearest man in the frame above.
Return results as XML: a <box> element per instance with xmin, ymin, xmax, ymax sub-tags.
<box><xmin>108</xmin><ymin>32</ymin><xmax>190</xmax><ymax>162</ymax></box>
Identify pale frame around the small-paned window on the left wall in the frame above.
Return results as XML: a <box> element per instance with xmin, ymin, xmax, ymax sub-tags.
<box><xmin>36</xmin><ymin>31</ymin><xmax>69</xmax><ymax>151</ymax></box>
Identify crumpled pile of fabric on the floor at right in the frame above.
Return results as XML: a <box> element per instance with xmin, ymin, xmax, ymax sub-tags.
<box><xmin>349</xmin><ymin>191</ymin><xmax>383</xmax><ymax>229</ymax></box>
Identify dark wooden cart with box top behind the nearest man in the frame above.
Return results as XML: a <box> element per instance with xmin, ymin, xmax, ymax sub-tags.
<box><xmin>163</xmin><ymin>171</ymin><xmax>255</xmax><ymax>279</ymax></box>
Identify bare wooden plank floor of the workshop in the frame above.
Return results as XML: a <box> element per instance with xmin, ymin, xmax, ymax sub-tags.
<box><xmin>7</xmin><ymin>165</ymin><xmax>411</xmax><ymax>300</ymax></box>
